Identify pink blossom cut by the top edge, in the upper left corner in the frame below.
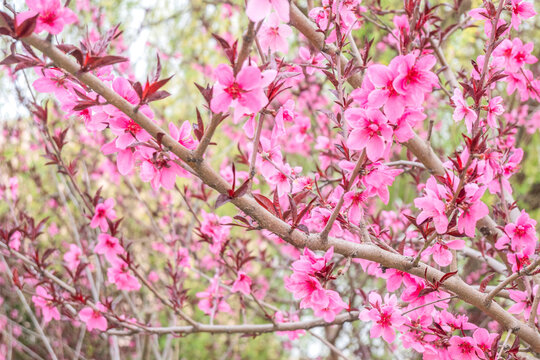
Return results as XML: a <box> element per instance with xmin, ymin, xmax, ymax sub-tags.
<box><xmin>26</xmin><ymin>0</ymin><xmax>77</xmax><ymax>35</ymax></box>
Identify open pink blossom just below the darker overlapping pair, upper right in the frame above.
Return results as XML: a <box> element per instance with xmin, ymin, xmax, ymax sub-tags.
<box><xmin>345</xmin><ymin>108</ymin><xmax>392</xmax><ymax>161</ymax></box>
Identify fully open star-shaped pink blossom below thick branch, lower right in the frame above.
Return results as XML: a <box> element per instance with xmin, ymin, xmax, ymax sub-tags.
<box><xmin>359</xmin><ymin>291</ymin><xmax>406</xmax><ymax>343</ymax></box>
